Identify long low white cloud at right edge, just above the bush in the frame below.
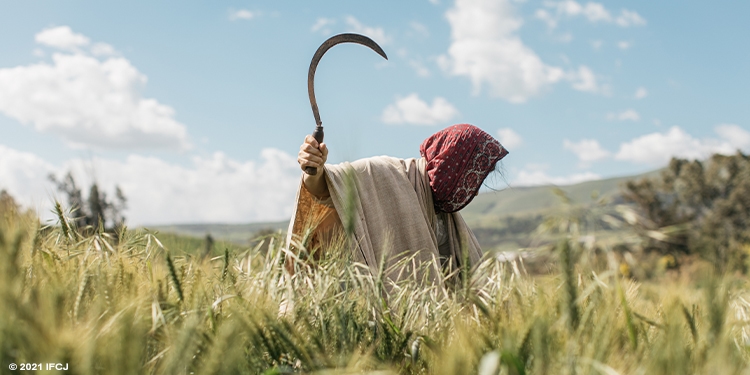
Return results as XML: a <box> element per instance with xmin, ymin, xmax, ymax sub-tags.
<box><xmin>615</xmin><ymin>124</ymin><xmax>750</xmax><ymax>166</ymax></box>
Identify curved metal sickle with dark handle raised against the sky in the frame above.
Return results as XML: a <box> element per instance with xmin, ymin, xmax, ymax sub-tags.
<box><xmin>305</xmin><ymin>34</ymin><xmax>388</xmax><ymax>176</ymax></box>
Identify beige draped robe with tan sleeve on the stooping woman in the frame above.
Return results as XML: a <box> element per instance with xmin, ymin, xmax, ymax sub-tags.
<box><xmin>287</xmin><ymin>156</ymin><xmax>482</xmax><ymax>281</ymax></box>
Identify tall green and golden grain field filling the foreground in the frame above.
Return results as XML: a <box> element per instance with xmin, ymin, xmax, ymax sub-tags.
<box><xmin>0</xmin><ymin>209</ymin><xmax>750</xmax><ymax>375</ymax></box>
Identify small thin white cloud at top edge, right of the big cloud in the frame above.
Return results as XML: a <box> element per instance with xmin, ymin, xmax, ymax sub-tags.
<box><xmin>535</xmin><ymin>0</ymin><xmax>646</xmax><ymax>28</ymax></box>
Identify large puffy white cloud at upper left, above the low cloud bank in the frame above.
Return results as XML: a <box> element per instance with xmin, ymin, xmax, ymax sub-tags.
<box><xmin>0</xmin><ymin>28</ymin><xmax>189</xmax><ymax>149</ymax></box>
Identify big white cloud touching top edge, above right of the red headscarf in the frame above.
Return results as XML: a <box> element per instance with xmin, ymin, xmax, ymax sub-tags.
<box><xmin>438</xmin><ymin>0</ymin><xmax>565</xmax><ymax>103</ymax></box>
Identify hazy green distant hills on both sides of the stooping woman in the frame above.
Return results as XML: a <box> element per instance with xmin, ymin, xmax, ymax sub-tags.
<box><xmin>149</xmin><ymin>171</ymin><xmax>659</xmax><ymax>248</ymax></box>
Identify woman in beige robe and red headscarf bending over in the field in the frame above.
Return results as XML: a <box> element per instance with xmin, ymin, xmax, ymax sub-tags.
<box><xmin>288</xmin><ymin>124</ymin><xmax>508</xmax><ymax>280</ymax></box>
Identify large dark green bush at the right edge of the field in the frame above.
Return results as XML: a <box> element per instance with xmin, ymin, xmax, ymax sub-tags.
<box><xmin>624</xmin><ymin>152</ymin><xmax>750</xmax><ymax>272</ymax></box>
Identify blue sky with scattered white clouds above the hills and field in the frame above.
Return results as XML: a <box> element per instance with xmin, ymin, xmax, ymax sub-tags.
<box><xmin>0</xmin><ymin>0</ymin><xmax>750</xmax><ymax>225</ymax></box>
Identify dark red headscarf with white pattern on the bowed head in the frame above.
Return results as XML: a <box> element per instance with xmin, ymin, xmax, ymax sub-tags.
<box><xmin>419</xmin><ymin>124</ymin><xmax>508</xmax><ymax>212</ymax></box>
